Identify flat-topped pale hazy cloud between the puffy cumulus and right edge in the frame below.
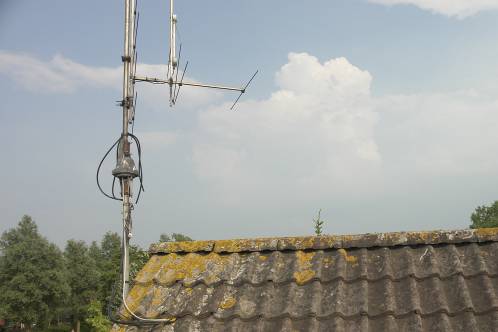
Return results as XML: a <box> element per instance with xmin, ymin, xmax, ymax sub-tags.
<box><xmin>375</xmin><ymin>91</ymin><xmax>498</xmax><ymax>178</ymax></box>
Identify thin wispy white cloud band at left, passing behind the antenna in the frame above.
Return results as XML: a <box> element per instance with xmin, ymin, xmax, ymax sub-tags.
<box><xmin>0</xmin><ymin>50</ymin><xmax>221</xmax><ymax>110</ymax></box>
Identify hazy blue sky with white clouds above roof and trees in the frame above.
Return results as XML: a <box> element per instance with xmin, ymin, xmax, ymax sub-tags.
<box><xmin>0</xmin><ymin>0</ymin><xmax>498</xmax><ymax>247</ymax></box>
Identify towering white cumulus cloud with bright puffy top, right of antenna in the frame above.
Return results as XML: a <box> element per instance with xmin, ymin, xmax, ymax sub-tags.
<box><xmin>193</xmin><ymin>53</ymin><xmax>381</xmax><ymax>202</ymax></box>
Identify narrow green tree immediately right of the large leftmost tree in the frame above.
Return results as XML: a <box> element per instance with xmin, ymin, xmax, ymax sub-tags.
<box><xmin>64</xmin><ymin>240</ymin><xmax>100</xmax><ymax>332</ymax></box>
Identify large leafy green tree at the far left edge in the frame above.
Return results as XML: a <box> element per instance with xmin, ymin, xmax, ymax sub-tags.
<box><xmin>0</xmin><ymin>216</ymin><xmax>69</xmax><ymax>329</ymax></box>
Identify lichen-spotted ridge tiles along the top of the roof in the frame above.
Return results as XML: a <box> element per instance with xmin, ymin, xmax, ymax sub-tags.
<box><xmin>149</xmin><ymin>228</ymin><xmax>498</xmax><ymax>255</ymax></box>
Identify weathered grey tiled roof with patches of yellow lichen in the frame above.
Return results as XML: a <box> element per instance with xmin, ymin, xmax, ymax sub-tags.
<box><xmin>111</xmin><ymin>229</ymin><xmax>498</xmax><ymax>332</ymax></box>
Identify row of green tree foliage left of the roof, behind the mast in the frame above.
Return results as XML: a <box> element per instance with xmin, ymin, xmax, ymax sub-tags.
<box><xmin>0</xmin><ymin>216</ymin><xmax>192</xmax><ymax>331</ymax></box>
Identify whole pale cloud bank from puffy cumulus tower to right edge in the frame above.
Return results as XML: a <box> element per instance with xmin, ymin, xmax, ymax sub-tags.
<box><xmin>188</xmin><ymin>53</ymin><xmax>498</xmax><ymax>208</ymax></box>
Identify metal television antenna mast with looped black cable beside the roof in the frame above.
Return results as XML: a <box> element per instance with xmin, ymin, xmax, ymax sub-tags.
<box><xmin>97</xmin><ymin>0</ymin><xmax>258</xmax><ymax>325</ymax></box>
